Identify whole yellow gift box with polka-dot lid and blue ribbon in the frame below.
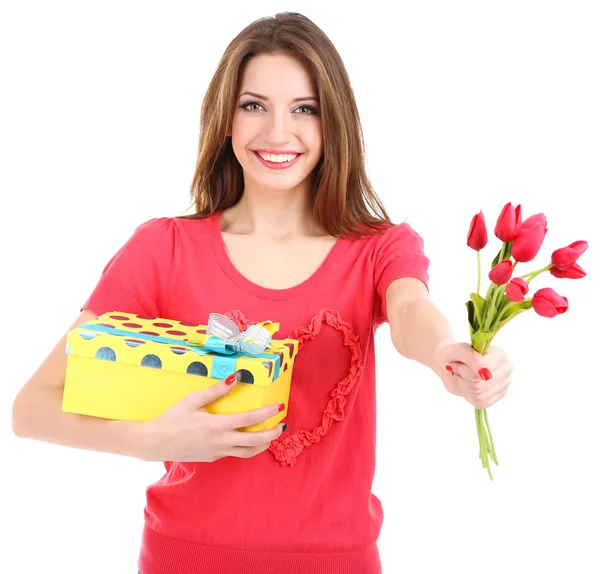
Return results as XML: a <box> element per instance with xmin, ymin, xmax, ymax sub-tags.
<box><xmin>62</xmin><ymin>311</ymin><xmax>298</xmax><ymax>431</ymax></box>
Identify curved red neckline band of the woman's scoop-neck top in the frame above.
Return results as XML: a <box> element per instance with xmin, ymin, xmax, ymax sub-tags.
<box><xmin>207</xmin><ymin>211</ymin><xmax>349</xmax><ymax>301</ymax></box>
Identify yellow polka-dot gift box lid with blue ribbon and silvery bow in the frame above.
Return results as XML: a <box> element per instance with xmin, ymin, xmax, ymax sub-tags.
<box><xmin>66</xmin><ymin>311</ymin><xmax>298</xmax><ymax>386</ymax></box>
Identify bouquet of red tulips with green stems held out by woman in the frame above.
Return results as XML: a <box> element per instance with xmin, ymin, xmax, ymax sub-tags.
<box><xmin>466</xmin><ymin>203</ymin><xmax>588</xmax><ymax>480</ymax></box>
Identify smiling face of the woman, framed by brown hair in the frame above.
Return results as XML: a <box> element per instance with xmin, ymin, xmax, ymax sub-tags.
<box><xmin>230</xmin><ymin>54</ymin><xmax>323</xmax><ymax>198</ymax></box>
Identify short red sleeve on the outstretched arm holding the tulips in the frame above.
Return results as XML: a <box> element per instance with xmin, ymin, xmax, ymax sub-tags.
<box><xmin>374</xmin><ymin>223</ymin><xmax>430</xmax><ymax>322</ymax></box>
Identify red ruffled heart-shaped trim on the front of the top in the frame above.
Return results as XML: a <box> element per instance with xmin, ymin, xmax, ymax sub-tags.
<box><xmin>225</xmin><ymin>309</ymin><xmax>363</xmax><ymax>467</ymax></box>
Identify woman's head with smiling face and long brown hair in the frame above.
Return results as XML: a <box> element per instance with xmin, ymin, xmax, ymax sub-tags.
<box><xmin>183</xmin><ymin>13</ymin><xmax>391</xmax><ymax>238</ymax></box>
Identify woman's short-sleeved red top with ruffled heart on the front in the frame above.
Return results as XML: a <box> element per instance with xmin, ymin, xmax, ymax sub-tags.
<box><xmin>82</xmin><ymin>213</ymin><xmax>429</xmax><ymax>574</ymax></box>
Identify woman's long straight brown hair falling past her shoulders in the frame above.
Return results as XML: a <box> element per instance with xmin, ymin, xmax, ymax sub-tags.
<box><xmin>181</xmin><ymin>12</ymin><xmax>391</xmax><ymax>237</ymax></box>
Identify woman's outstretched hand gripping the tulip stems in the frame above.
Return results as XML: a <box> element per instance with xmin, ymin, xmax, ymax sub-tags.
<box><xmin>436</xmin><ymin>343</ymin><xmax>513</xmax><ymax>409</ymax></box>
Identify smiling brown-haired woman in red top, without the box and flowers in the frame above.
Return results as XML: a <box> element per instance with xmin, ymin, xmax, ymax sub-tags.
<box><xmin>13</xmin><ymin>13</ymin><xmax>511</xmax><ymax>574</ymax></box>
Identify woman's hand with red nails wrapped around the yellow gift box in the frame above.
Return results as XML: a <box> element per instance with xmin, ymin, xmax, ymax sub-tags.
<box><xmin>137</xmin><ymin>374</ymin><xmax>285</xmax><ymax>462</ymax></box>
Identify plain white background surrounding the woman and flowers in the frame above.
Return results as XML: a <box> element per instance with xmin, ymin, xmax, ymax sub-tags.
<box><xmin>0</xmin><ymin>0</ymin><xmax>600</xmax><ymax>574</ymax></box>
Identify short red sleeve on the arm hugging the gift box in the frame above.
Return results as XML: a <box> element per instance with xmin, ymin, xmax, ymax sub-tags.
<box><xmin>81</xmin><ymin>217</ymin><xmax>180</xmax><ymax>316</ymax></box>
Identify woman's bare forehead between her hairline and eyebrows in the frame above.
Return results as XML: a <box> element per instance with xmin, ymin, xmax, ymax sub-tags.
<box><xmin>239</xmin><ymin>54</ymin><xmax>314</xmax><ymax>98</ymax></box>
